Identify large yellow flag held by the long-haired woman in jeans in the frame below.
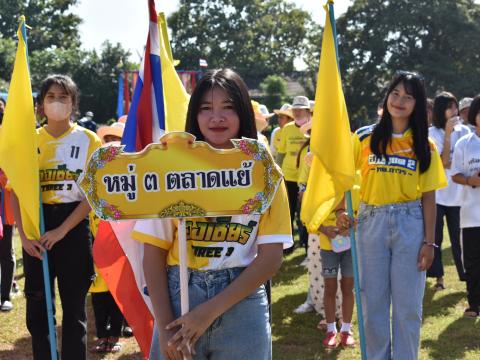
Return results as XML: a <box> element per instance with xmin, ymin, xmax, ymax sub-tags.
<box><xmin>301</xmin><ymin>1</ymin><xmax>355</xmax><ymax>232</ymax></box>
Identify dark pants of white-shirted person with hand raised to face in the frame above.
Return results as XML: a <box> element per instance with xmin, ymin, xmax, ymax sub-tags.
<box><xmin>427</xmin><ymin>204</ymin><xmax>465</xmax><ymax>281</ymax></box>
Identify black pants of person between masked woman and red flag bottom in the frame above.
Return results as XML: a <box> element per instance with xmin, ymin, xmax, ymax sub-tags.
<box><xmin>92</xmin><ymin>291</ymin><xmax>123</xmax><ymax>339</ymax></box>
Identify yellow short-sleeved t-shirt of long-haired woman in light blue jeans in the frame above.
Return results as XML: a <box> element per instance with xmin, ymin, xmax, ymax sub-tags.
<box><xmin>353</xmin><ymin>125</ymin><xmax>447</xmax><ymax>206</ymax></box>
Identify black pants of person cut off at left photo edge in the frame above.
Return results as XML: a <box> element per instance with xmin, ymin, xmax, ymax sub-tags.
<box><xmin>0</xmin><ymin>225</ymin><xmax>15</xmax><ymax>302</ymax></box>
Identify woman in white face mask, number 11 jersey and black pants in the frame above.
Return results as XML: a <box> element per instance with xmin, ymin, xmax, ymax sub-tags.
<box><xmin>13</xmin><ymin>75</ymin><xmax>101</xmax><ymax>360</ymax></box>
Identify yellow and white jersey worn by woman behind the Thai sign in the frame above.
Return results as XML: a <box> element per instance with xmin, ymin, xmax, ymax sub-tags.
<box><xmin>131</xmin><ymin>182</ymin><xmax>293</xmax><ymax>270</ymax></box>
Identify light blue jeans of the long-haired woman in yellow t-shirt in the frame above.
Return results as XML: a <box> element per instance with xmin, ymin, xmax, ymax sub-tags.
<box><xmin>358</xmin><ymin>201</ymin><xmax>425</xmax><ymax>360</ymax></box>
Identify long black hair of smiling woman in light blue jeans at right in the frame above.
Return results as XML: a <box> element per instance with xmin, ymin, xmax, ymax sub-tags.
<box><xmin>370</xmin><ymin>71</ymin><xmax>432</xmax><ymax>173</ymax></box>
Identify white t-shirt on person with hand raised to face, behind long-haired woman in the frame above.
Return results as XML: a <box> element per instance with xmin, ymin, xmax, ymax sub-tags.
<box><xmin>428</xmin><ymin>125</ymin><xmax>470</xmax><ymax>206</ymax></box>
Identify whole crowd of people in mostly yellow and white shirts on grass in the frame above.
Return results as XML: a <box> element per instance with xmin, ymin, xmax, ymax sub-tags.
<box><xmin>0</xmin><ymin>69</ymin><xmax>480</xmax><ymax>359</ymax></box>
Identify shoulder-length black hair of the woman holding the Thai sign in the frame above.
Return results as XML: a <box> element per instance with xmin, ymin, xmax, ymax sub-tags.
<box><xmin>185</xmin><ymin>69</ymin><xmax>257</xmax><ymax>140</ymax></box>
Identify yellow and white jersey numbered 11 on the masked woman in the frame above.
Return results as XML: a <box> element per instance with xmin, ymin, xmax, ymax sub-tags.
<box><xmin>37</xmin><ymin>124</ymin><xmax>102</xmax><ymax>204</ymax></box>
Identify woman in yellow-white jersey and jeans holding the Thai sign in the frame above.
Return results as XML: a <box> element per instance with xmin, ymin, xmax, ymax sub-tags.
<box><xmin>132</xmin><ymin>69</ymin><xmax>293</xmax><ymax>360</ymax></box>
